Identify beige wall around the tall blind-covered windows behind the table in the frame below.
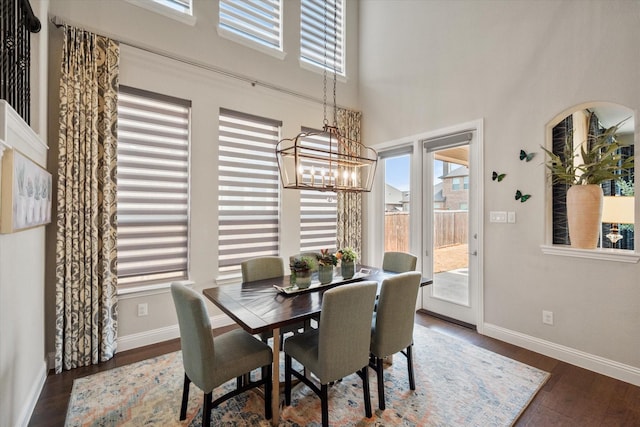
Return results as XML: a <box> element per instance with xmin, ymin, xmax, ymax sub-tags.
<box><xmin>46</xmin><ymin>0</ymin><xmax>358</xmax><ymax>352</ymax></box>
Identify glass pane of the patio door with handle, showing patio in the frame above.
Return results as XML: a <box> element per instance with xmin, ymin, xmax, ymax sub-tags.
<box><xmin>432</xmin><ymin>145</ymin><xmax>469</xmax><ymax>305</ymax></box>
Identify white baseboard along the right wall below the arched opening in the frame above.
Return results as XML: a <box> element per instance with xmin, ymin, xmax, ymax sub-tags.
<box><xmin>482</xmin><ymin>323</ymin><xmax>640</xmax><ymax>386</ymax></box>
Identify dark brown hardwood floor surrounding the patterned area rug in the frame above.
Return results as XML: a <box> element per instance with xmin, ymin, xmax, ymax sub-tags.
<box><xmin>29</xmin><ymin>313</ymin><xmax>640</xmax><ymax>427</ymax></box>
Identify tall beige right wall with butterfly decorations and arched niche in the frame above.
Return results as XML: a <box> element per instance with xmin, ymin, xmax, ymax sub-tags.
<box><xmin>359</xmin><ymin>0</ymin><xmax>640</xmax><ymax>381</ymax></box>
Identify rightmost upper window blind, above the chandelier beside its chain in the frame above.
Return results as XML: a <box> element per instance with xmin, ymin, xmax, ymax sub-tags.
<box><xmin>300</xmin><ymin>0</ymin><xmax>345</xmax><ymax>75</ymax></box>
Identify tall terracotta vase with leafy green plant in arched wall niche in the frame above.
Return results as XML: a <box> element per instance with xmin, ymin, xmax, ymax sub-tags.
<box><xmin>542</xmin><ymin>119</ymin><xmax>634</xmax><ymax>249</ymax></box>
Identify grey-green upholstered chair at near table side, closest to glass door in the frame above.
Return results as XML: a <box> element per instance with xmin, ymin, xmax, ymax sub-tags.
<box><xmin>370</xmin><ymin>271</ymin><xmax>422</xmax><ymax>410</ymax></box>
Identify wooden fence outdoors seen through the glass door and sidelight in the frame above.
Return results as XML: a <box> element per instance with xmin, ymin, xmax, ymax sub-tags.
<box><xmin>384</xmin><ymin>211</ymin><xmax>469</xmax><ymax>252</ymax></box>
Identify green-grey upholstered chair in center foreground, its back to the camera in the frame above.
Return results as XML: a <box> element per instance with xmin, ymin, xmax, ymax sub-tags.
<box><xmin>284</xmin><ymin>282</ymin><xmax>378</xmax><ymax>427</ymax></box>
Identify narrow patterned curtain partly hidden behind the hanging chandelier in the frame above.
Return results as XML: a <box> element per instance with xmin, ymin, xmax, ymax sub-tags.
<box><xmin>336</xmin><ymin>108</ymin><xmax>362</xmax><ymax>257</ymax></box>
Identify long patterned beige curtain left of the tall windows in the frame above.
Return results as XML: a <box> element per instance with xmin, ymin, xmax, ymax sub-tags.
<box><xmin>55</xmin><ymin>26</ymin><xmax>120</xmax><ymax>373</ymax></box>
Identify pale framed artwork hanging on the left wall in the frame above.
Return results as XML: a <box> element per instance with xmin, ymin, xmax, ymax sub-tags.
<box><xmin>0</xmin><ymin>149</ymin><xmax>52</xmax><ymax>233</ymax></box>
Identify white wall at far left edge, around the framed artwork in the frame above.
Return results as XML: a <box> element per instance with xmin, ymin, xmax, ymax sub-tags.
<box><xmin>0</xmin><ymin>2</ymin><xmax>51</xmax><ymax>426</ymax></box>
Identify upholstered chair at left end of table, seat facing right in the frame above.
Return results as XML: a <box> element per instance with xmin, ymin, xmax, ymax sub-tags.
<box><xmin>171</xmin><ymin>282</ymin><xmax>273</xmax><ymax>426</ymax></box>
